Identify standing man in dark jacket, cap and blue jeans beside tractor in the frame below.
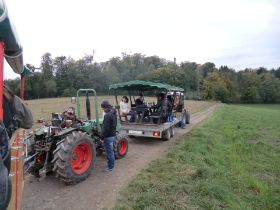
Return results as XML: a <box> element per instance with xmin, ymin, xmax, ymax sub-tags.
<box><xmin>101</xmin><ymin>100</ymin><xmax>117</xmax><ymax>171</ymax></box>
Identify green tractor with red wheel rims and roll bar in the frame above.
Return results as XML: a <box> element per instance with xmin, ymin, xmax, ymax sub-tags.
<box><xmin>25</xmin><ymin>89</ymin><xmax>128</xmax><ymax>184</ymax></box>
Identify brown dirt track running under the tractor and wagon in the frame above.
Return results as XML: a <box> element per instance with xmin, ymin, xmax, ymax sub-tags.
<box><xmin>23</xmin><ymin>105</ymin><xmax>216</xmax><ymax>210</ymax></box>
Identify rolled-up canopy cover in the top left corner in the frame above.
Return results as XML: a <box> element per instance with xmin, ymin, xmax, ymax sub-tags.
<box><xmin>0</xmin><ymin>0</ymin><xmax>24</xmax><ymax>74</ymax></box>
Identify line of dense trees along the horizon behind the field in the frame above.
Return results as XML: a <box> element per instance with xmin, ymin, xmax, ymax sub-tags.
<box><xmin>5</xmin><ymin>53</ymin><xmax>280</xmax><ymax>103</ymax></box>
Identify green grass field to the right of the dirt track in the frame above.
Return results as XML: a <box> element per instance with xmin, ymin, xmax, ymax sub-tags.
<box><xmin>114</xmin><ymin>105</ymin><xmax>280</xmax><ymax>210</ymax></box>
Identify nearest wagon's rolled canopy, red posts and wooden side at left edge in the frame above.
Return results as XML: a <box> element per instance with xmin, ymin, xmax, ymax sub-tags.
<box><xmin>0</xmin><ymin>0</ymin><xmax>30</xmax><ymax>210</ymax></box>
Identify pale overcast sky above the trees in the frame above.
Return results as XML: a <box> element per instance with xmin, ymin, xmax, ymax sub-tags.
<box><xmin>2</xmin><ymin>0</ymin><xmax>280</xmax><ymax>78</ymax></box>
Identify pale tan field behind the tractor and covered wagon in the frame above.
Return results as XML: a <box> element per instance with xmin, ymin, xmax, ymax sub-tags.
<box><xmin>27</xmin><ymin>96</ymin><xmax>216</xmax><ymax>124</ymax></box>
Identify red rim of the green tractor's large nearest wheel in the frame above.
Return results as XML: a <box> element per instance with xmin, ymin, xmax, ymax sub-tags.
<box><xmin>71</xmin><ymin>142</ymin><xmax>92</xmax><ymax>174</ymax></box>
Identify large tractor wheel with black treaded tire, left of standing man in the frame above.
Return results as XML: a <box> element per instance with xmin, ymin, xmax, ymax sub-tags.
<box><xmin>52</xmin><ymin>131</ymin><xmax>96</xmax><ymax>184</ymax></box>
